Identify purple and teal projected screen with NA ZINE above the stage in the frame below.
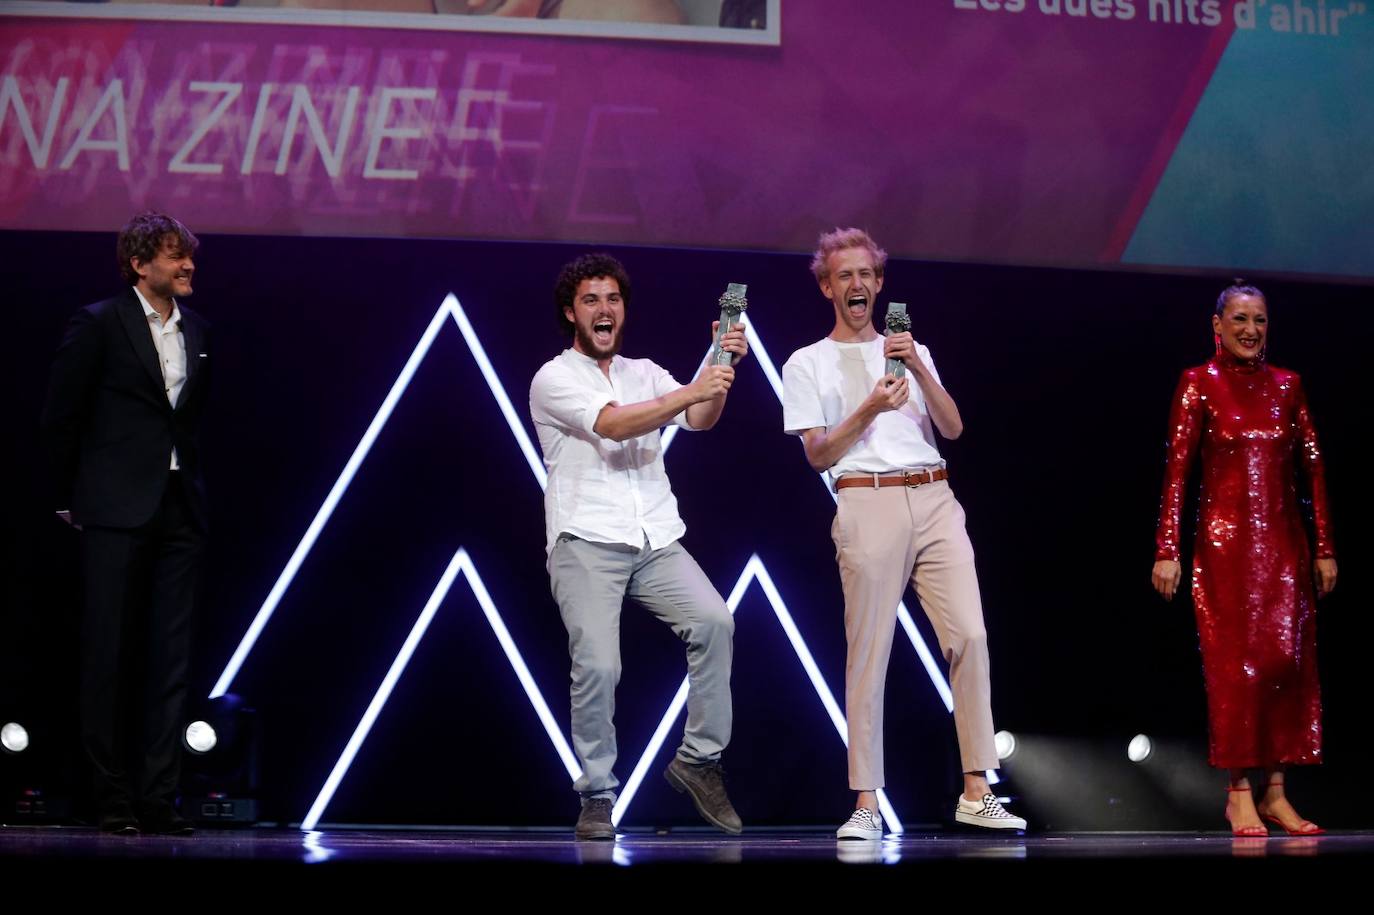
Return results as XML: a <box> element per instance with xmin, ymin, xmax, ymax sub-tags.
<box><xmin>0</xmin><ymin>0</ymin><xmax>1374</xmax><ymax>276</ymax></box>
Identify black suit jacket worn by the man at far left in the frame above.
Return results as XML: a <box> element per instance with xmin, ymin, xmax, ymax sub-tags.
<box><xmin>41</xmin><ymin>287</ymin><xmax>210</xmax><ymax>530</ymax></box>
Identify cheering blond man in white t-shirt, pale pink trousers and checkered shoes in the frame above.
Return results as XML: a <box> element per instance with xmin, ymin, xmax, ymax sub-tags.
<box><xmin>782</xmin><ymin>228</ymin><xmax>1026</xmax><ymax>839</ymax></box>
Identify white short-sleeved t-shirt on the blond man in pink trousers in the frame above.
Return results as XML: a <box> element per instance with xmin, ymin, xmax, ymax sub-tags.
<box><xmin>782</xmin><ymin>337</ymin><xmax>944</xmax><ymax>479</ymax></box>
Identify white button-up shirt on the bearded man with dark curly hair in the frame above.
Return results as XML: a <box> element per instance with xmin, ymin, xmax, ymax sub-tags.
<box><xmin>529</xmin><ymin>349</ymin><xmax>691</xmax><ymax>552</ymax></box>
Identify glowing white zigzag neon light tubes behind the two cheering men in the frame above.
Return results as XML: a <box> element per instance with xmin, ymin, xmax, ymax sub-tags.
<box><xmin>210</xmin><ymin>293</ymin><xmax>952</xmax><ymax>830</ymax></box>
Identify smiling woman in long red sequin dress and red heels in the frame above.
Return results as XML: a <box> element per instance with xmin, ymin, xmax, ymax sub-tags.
<box><xmin>1153</xmin><ymin>286</ymin><xmax>1336</xmax><ymax>835</ymax></box>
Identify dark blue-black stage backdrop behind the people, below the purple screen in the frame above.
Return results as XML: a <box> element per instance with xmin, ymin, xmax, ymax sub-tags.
<box><xmin>0</xmin><ymin>232</ymin><xmax>1371</xmax><ymax>826</ymax></box>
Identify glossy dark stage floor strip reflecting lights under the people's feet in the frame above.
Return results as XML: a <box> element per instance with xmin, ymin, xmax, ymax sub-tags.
<box><xmin>0</xmin><ymin>827</ymin><xmax>1374</xmax><ymax>872</ymax></box>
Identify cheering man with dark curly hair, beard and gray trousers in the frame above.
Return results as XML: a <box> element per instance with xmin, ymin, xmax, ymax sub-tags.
<box><xmin>529</xmin><ymin>254</ymin><xmax>747</xmax><ymax>839</ymax></box>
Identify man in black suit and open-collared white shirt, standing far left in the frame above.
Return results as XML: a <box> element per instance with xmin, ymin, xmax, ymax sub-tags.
<box><xmin>43</xmin><ymin>213</ymin><xmax>209</xmax><ymax>834</ymax></box>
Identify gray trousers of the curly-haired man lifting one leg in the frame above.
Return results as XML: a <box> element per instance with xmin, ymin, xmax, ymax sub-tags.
<box><xmin>548</xmin><ymin>533</ymin><xmax>735</xmax><ymax>798</ymax></box>
